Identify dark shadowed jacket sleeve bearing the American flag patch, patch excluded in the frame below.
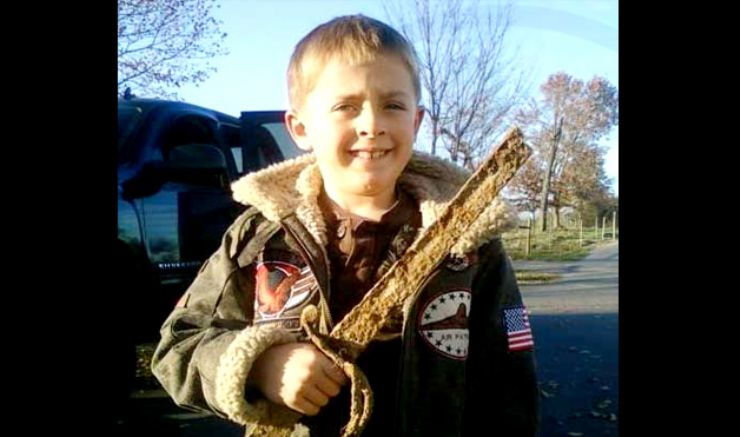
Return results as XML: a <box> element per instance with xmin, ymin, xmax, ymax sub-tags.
<box><xmin>463</xmin><ymin>239</ymin><xmax>539</xmax><ymax>436</ymax></box>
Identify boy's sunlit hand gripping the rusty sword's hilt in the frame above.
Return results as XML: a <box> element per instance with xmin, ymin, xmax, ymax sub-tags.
<box><xmin>249</xmin><ymin>343</ymin><xmax>347</xmax><ymax>416</ymax></box>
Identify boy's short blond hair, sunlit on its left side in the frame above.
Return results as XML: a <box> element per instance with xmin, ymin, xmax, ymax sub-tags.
<box><xmin>288</xmin><ymin>15</ymin><xmax>421</xmax><ymax>110</ymax></box>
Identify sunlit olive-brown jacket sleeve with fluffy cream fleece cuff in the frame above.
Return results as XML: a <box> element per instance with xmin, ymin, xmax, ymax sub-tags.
<box><xmin>152</xmin><ymin>209</ymin><xmax>295</xmax><ymax>425</ymax></box>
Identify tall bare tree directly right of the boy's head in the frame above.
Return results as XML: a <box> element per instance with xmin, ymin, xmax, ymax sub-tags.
<box><xmin>384</xmin><ymin>0</ymin><xmax>526</xmax><ymax>168</ymax></box>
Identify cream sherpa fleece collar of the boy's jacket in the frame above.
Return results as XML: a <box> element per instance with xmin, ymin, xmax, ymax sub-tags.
<box><xmin>231</xmin><ymin>151</ymin><xmax>516</xmax><ymax>255</ymax></box>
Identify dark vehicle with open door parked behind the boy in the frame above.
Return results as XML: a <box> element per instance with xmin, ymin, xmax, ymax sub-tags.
<box><xmin>115</xmin><ymin>98</ymin><xmax>301</xmax><ymax>396</ymax></box>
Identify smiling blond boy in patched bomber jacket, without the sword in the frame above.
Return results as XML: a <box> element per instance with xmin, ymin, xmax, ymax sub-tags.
<box><xmin>152</xmin><ymin>15</ymin><xmax>538</xmax><ymax>437</ymax></box>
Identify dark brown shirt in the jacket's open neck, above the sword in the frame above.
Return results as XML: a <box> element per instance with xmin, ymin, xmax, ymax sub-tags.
<box><xmin>319</xmin><ymin>190</ymin><xmax>421</xmax><ymax>323</ymax></box>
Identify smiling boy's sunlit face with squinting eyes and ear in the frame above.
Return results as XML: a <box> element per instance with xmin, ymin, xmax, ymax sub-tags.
<box><xmin>285</xmin><ymin>55</ymin><xmax>424</xmax><ymax>204</ymax></box>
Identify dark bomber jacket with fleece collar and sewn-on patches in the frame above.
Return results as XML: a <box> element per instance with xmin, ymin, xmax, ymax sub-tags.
<box><xmin>152</xmin><ymin>151</ymin><xmax>538</xmax><ymax>437</ymax></box>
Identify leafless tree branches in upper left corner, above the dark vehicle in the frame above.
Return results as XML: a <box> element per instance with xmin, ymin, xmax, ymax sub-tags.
<box><xmin>118</xmin><ymin>0</ymin><xmax>227</xmax><ymax>97</ymax></box>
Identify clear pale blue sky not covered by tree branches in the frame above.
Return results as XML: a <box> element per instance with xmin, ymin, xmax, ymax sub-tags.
<box><xmin>177</xmin><ymin>0</ymin><xmax>619</xmax><ymax>195</ymax></box>
